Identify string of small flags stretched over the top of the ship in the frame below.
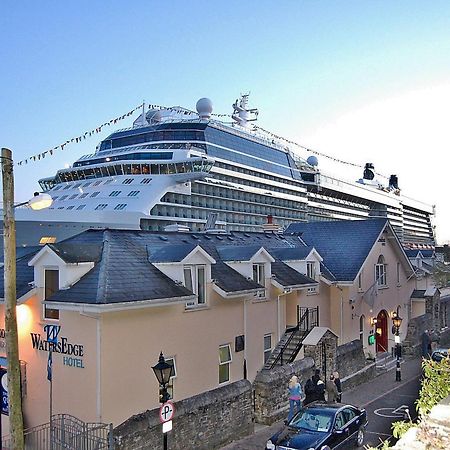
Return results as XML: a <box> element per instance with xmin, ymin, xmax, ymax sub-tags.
<box><xmin>17</xmin><ymin>103</ymin><xmax>388</xmax><ymax>178</ymax></box>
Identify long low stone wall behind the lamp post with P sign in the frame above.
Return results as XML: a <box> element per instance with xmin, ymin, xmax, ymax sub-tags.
<box><xmin>114</xmin><ymin>380</ymin><xmax>254</xmax><ymax>450</ymax></box>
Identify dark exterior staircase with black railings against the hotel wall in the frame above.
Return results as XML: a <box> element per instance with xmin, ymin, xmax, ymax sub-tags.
<box><xmin>263</xmin><ymin>307</ymin><xmax>319</xmax><ymax>370</ymax></box>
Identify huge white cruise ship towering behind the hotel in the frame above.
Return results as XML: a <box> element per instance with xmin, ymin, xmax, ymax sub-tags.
<box><xmin>11</xmin><ymin>95</ymin><xmax>435</xmax><ymax>246</ymax></box>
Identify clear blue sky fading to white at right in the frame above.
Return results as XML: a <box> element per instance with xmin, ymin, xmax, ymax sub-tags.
<box><xmin>0</xmin><ymin>0</ymin><xmax>450</xmax><ymax>244</ymax></box>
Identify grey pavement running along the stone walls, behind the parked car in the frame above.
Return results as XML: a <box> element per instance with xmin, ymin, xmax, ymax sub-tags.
<box><xmin>221</xmin><ymin>358</ymin><xmax>422</xmax><ymax>450</ymax></box>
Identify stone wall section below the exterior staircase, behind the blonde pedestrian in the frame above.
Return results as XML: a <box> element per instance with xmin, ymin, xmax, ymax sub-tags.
<box><xmin>253</xmin><ymin>358</ymin><xmax>314</xmax><ymax>425</ymax></box>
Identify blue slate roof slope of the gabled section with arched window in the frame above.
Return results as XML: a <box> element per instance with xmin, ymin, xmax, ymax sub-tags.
<box><xmin>286</xmin><ymin>219</ymin><xmax>388</xmax><ymax>281</ymax></box>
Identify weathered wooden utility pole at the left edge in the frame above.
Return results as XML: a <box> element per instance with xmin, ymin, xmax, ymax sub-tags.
<box><xmin>1</xmin><ymin>148</ymin><xmax>24</xmax><ymax>450</ymax></box>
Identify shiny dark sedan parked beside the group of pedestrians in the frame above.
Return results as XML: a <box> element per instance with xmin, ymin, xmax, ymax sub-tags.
<box><xmin>266</xmin><ymin>402</ymin><xmax>367</xmax><ymax>450</ymax></box>
